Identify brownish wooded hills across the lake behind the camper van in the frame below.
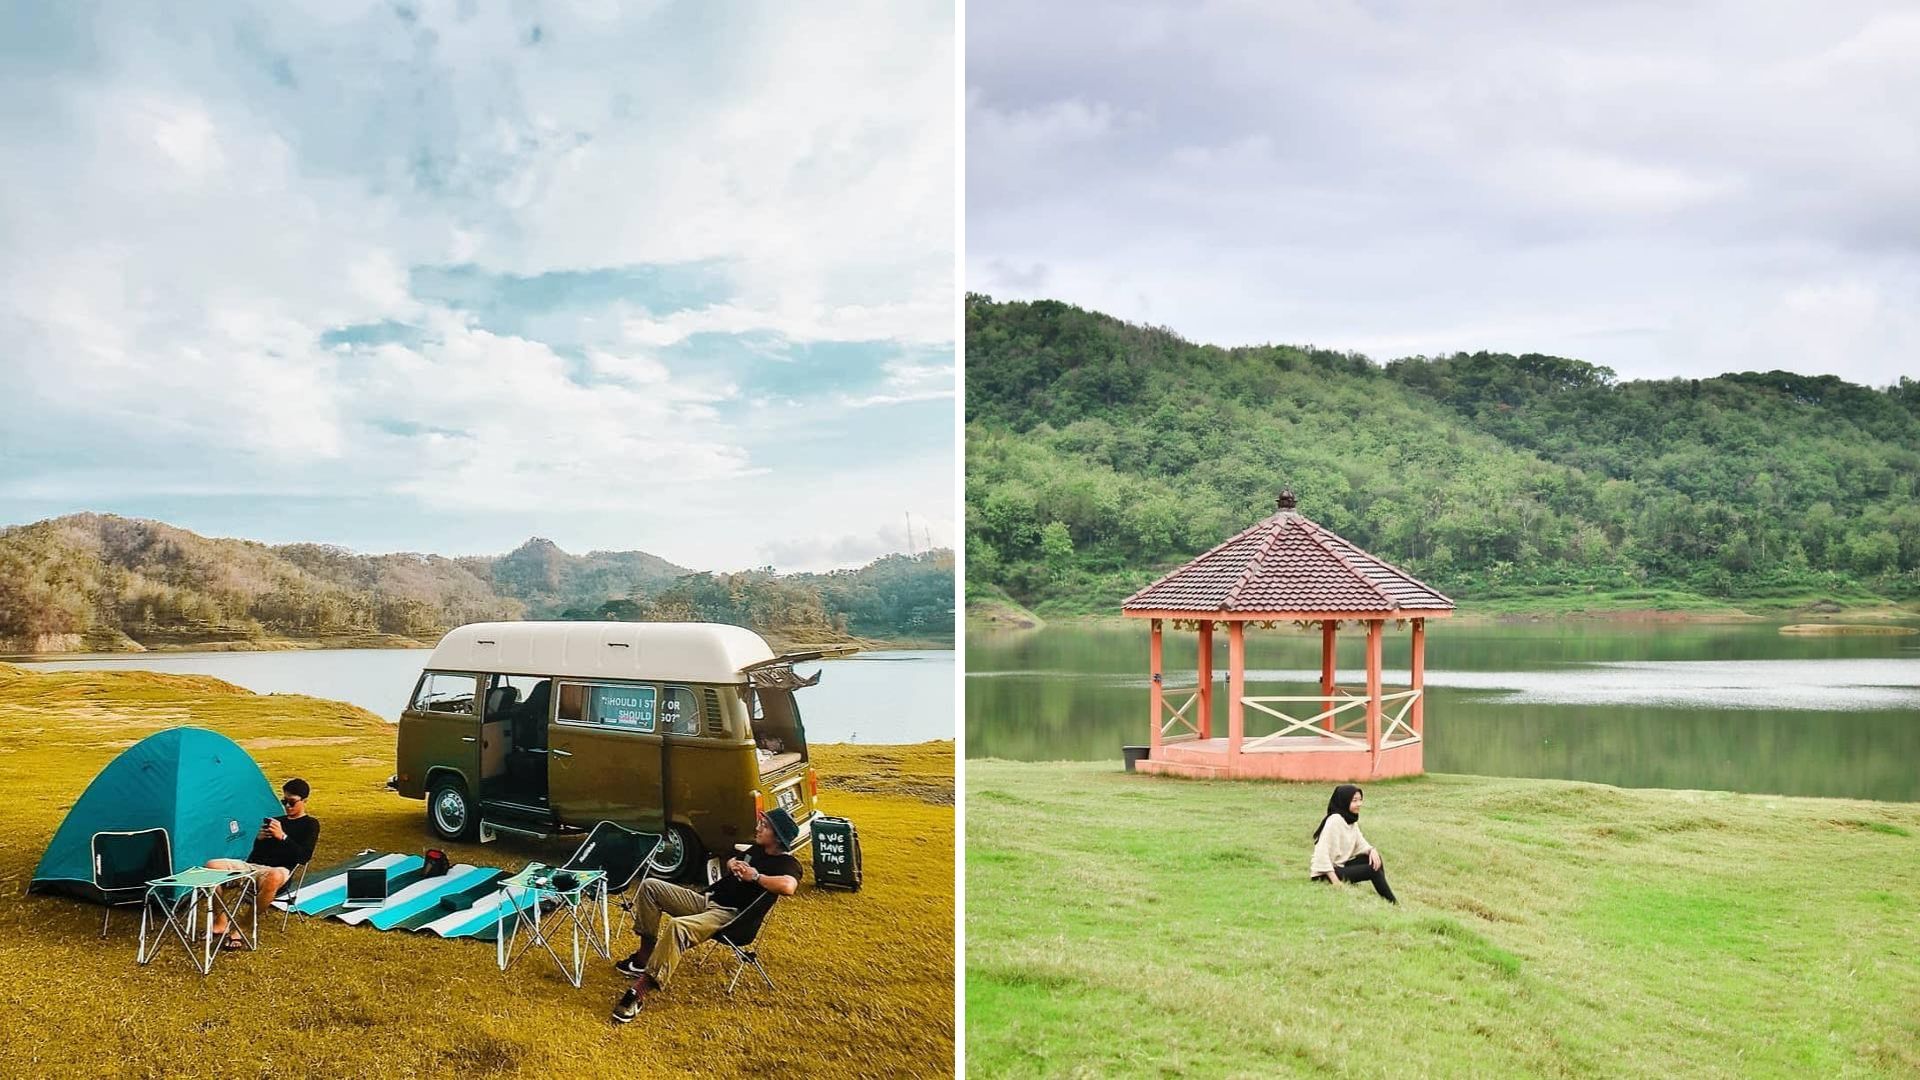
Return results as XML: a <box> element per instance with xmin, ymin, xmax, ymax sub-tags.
<box><xmin>0</xmin><ymin>513</ymin><xmax>954</xmax><ymax>653</ymax></box>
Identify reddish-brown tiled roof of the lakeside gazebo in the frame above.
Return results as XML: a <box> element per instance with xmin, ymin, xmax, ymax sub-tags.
<box><xmin>1121</xmin><ymin>496</ymin><xmax>1453</xmax><ymax>615</ymax></box>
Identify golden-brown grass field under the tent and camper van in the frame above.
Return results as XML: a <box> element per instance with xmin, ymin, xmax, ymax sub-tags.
<box><xmin>0</xmin><ymin>665</ymin><xmax>954</xmax><ymax>1078</ymax></box>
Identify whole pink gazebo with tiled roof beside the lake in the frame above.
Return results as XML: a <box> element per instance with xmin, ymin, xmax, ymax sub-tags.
<box><xmin>1121</xmin><ymin>492</ymin><xmax>1453</xmax><ymax>780</ymax></box>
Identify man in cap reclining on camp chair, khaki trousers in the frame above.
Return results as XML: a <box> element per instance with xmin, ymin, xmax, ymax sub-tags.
<box><xmin>612</xmin><ymin>807</ymin><xmax>801</xmax><ymax>1024</ymax></box>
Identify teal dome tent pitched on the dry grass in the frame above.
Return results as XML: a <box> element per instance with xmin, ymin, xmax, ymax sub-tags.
<box><xmin>27</xmin><ymin>728</ymin><xmax>280</xmax><ymax>901</ymax></box>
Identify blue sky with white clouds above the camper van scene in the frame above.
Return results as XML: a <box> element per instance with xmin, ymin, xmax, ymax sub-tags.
<box><xmin>0</xmin><ymin>0</ymin><xmax>956</xmax><ymax>569</ymax></box>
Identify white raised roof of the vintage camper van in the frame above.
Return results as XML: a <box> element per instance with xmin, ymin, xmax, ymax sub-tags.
<box><xmin>426</xmin><ymin>623</ymin><xmax>774</xmax><ymax>682</ymax></box>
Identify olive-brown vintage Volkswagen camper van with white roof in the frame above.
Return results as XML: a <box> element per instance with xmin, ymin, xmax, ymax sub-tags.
<box><xmin>390</xmin><ymin>623</ymin><xmax>820</xmax><ymax>878</ymax></box>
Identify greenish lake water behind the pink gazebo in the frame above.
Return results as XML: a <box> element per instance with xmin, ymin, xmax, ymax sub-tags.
<box><xmin>966</xmin><ymin>621</ymin><xmax>1920</xmax><ymax>801</ymax></box>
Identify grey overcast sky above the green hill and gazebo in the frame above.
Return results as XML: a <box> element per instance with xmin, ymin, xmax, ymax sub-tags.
<box><xmin>966</xmin><ymin>0</ymin><xmax>1920</xmax><ymax>384</ymax></box>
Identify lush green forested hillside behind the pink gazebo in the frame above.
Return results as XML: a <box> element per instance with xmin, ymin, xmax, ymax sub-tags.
<box><xmin>966</xmin><ymin>296</ymin><xmax>1920</xmax><ymax>615</ymax></box>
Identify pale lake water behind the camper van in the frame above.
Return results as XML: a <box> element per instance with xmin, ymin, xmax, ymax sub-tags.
<box><xmin>12</xmin><ymin>650</ymin><xmax>954</xmax><ymax>744</ymax></box>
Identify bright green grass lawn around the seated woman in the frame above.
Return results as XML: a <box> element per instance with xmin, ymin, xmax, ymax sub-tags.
<box><xmin>966</xmin><ymin>761</ymin><xmax>1920</xmax><ymax>1076</ymax></box>
